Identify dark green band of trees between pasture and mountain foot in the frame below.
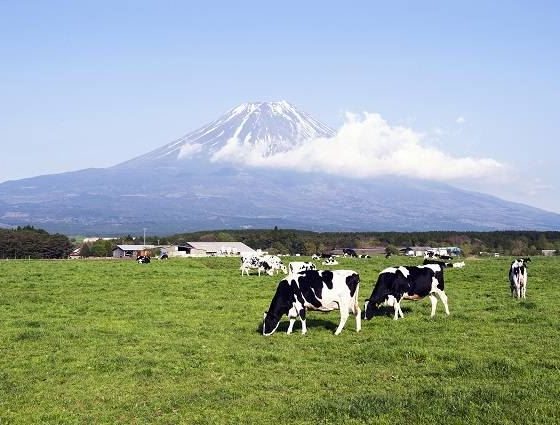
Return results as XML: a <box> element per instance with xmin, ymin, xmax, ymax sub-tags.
<box><xmin>0</xmin><ymin>226</ymin><xmax>560</xmax><ymax>259</ymax></box>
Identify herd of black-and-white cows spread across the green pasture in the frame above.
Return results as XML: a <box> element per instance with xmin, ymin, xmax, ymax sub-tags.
<box><xmin>240</xmin><ymin>250</ymin><xmax>531</xmax><ymax>336</ymax></box>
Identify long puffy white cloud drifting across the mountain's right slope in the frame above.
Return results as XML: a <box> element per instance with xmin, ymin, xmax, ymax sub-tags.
<box><xmin>209</xmin><ymin>113</ymin><xmax>506</xmax><ymax>181</ymax></box>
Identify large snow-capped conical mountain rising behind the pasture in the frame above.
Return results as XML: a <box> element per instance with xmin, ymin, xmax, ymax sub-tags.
<box><xmin>0</xmin><ymin>101</ymin><xmax>560</xmax><ymax>235</ymax></box>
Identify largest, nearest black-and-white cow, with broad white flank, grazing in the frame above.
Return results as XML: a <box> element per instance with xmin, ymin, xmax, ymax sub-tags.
<box><xmin>263</xmin><ymin>270</ymin><xmax>362</xmax><ymax>336</ymax></box>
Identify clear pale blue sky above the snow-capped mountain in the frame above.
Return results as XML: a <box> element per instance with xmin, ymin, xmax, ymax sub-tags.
<box><xmin>0</xmin><ymin>0</ymin><xmax>560</xmax><ymax>212</ymax></box>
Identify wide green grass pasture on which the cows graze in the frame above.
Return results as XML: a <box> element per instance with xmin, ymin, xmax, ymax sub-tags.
<box><xmin>0</xmin><ymin>253</ymin><xmax>560</xmax><ymax>424</ymax></box>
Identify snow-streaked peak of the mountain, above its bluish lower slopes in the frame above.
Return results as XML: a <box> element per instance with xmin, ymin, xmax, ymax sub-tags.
<box><xmin>117</xmin><ymin>100</ymin><xmax>335</xmax><ymax>167</ymax></box>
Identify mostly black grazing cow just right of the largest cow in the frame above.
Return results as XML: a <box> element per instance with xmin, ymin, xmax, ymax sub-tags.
<box><xmin>364</xmin><ymin>264</ymin><xmax>449</xmax><ymax>320</ymax></box>
